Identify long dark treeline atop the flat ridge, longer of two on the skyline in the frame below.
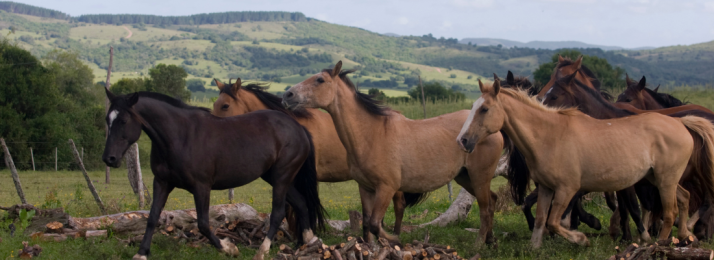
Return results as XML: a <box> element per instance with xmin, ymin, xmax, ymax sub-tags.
<box><xmin>77</xmin><ymin>11</ymin><xmax>308</xmax><ymax>25</ymax></box>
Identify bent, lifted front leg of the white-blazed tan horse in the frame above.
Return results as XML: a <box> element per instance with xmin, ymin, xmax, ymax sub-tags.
<box><xmin>539</xmin><ymin>187</ymin><xmax>590</xmax><ymax>246</ymax></box>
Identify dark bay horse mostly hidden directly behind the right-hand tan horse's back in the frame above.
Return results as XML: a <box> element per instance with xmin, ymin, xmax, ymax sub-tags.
<box><xmin>544</xmin><ymin>70</ymin><xmax>714</xmax><ymax>239</ymax></box>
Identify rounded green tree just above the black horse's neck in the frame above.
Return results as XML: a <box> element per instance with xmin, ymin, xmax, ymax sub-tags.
<box><xmin>147</xmin><ymin>64</ymin><xmax>191</xmax><ymax>101</ymax></box>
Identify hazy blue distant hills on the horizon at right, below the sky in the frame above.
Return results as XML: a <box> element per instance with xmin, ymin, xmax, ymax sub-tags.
<box><xmin>459</xmin><ymin>38</ymin><xmax>624</xmax><ymax>51</ymax></box>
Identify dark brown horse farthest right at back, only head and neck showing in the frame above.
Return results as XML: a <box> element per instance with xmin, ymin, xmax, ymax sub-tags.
<box><xmin>617</xmin><ymin>74</ymin><xmax>714</xmax><ymax>114</ymax></box>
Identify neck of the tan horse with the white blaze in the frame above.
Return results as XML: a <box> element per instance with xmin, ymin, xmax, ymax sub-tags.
<box><xmin>500</xmin><ymin>95</ymin><xmax>567</xmax><ymax>164</ymax></box>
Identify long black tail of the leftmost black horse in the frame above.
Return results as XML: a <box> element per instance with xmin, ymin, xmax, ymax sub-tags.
<box><xmin>293</xmin><ymin>127</ymin><xmax>327</xmax><ymax>231</ymax></box>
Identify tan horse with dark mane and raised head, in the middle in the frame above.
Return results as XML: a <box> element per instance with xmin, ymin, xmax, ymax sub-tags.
<box><xmin>283</xmin><ymin>61</ymin><xmax>503</xmax><ymax>245</ymax></box>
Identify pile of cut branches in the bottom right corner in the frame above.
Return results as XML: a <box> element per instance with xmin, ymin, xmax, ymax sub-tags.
<box><xmin>610</xmin><ymin>236</ymin><xmax>714</xmax><ymax>260</ymax></box>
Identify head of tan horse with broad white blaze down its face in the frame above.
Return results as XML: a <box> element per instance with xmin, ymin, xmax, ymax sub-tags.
<box><xmin>456</xmin><ymin>74</ymin><xmax>506</xmax><ymax>153</ymax></box>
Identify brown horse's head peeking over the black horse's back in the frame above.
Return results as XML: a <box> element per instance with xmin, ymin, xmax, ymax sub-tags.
<box><xmin>211</xmin><ymin>78</ymin><xmax>253</xmax><ymax>117</ymax></box>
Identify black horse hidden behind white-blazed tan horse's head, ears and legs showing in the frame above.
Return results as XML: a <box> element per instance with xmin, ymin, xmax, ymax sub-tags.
<box><xmin>496</xmin><ymin>70</ymin><xmax>614</xmax><ymax>231</ymax></box>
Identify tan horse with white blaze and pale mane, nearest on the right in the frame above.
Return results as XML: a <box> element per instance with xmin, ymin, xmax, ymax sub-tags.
<box><xmin>455</xmin><ymin>75</ymin><xmax>714</xmax><ymax>248</ymax></box>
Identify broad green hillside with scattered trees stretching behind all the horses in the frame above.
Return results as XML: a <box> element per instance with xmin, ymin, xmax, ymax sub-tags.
<box><xmin>0</xmin><ymin>2</ymin><xmax>714</xmax><ymax>92</ymax></box>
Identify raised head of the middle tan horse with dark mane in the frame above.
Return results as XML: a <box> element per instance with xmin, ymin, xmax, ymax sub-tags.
<box><xmin>283</xmin><ymin>61</ymin><xmax>344</xmax><ymax>110</ymax></box>
